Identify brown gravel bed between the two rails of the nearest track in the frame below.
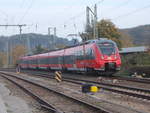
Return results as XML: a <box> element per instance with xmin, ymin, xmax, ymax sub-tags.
<box><xmin>5</xmin><ymin>74</ymin><xmax>99</xmax><ymax>113</ymax></box>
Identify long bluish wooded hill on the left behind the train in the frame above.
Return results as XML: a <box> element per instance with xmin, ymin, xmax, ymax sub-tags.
<box><xmin>0</xmin><ymin>33</ymin><xmax>79</xmax><ymax>52</ymax></box>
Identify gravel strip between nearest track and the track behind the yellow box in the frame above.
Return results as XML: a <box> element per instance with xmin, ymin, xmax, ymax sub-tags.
<box><xmin>2</xmin><ymin>71</ymin><xmax>147</xmax><ymax>113</ymax></box>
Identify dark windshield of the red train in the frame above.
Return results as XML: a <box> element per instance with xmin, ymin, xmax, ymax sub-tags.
<box><xmin>98</xmin><ymin>43</ymin><xmax>116</xmax><ymax>55</ymax></box>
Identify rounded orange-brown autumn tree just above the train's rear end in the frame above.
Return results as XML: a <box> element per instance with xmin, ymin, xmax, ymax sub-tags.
<box><xmin>12</xmin><ymin>45</ymin><xmax>27</xmax><ymax>65</ymax></box>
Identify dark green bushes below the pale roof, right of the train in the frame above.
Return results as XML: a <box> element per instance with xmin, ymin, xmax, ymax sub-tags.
<box><xmin>116</xmin><ymin>52</ymin><xmax>150</xmax><ymax>76</ymax></box>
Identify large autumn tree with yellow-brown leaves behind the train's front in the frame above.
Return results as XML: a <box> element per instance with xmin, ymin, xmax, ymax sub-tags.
<box><xmin>80</xmin><ymin>19</ymin><xmax>122</xmax><ymax>48</ymax></box>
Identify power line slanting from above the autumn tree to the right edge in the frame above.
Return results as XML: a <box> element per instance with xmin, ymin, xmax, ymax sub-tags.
<box><xmin>111</xmin><ymin>4</ymin><xmax>150</xmax><ymax>20</ymax></box>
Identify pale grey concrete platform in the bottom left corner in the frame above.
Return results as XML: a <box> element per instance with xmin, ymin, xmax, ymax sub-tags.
<box><xmin>0</xmin><ymin>82</ymin><xmax>32</xmax><ymax>113</ymax></box>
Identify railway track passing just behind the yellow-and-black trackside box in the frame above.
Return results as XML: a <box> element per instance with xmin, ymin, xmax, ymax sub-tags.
<box><xmin>18</xmin><ymin>71</ymin><xmax>150</xmax><ymax>100</ymax></box>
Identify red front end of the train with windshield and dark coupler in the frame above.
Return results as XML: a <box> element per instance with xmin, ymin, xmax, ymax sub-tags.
<box><xmin>96</xmin><ymin>40</ymin><xmax>121</xmax><ymax>72</ymax></box>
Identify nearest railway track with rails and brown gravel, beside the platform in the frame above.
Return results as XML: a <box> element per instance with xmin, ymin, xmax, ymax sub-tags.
<box><xmin>0</xmin><ymin>72</ymin><xmax>112</xmax><ymax>113</ymax></box>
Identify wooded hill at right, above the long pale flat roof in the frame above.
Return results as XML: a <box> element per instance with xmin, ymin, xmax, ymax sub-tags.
<box><xmin>120</xmin><ymin>25</ymin><xmax>150</xmax><ymax>45</ymax></box>
